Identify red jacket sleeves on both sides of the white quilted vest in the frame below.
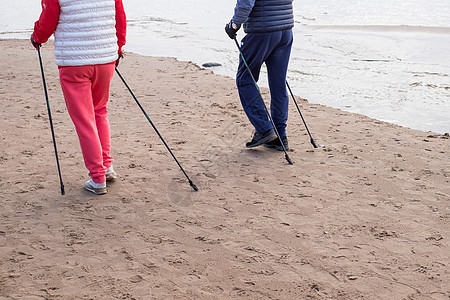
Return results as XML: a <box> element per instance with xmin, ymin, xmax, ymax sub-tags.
<box><xmin>33</xmin><ymin>0</ymin><xmax>127</xmax><ymax>52</ymax></box>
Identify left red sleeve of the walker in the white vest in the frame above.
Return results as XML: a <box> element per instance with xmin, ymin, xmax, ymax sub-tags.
<box><xmin>33</xmin><ymin>0</ymin><xmax>59</xmax><ymax>44</ymax></box>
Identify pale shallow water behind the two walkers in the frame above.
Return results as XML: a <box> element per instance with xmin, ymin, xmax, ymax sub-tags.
<box><xmin>0</xmin><ymin>0</ymin><xmax>450</xmax><ymax>133</ymax></box>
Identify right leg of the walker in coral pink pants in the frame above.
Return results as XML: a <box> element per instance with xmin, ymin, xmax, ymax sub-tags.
<box><xmin>92</xmin><ymin>63</ymin><xmax>114</xmax><ymax>168</ymax></box>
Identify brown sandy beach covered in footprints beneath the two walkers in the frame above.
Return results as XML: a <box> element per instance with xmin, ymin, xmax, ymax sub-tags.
<box><xmin>0</xmin><ymin>40</ymin><xmax>450</xmax><ymax>300</ymax></box>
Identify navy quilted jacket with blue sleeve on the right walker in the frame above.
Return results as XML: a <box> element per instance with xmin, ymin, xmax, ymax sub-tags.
<box><xmin>232</xmin><ymin>0</ymin><xmax>294</xmax><ymax>33</ymax></box>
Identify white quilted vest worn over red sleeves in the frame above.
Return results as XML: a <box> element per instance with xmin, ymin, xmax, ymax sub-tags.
<box><xmin>55</xmin><ymin>0</ymin><xmax>118</xmax><ymax>66</ymax></box>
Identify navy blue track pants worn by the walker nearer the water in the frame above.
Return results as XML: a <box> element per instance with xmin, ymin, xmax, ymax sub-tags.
<box><xmin>236</xmin><ymin>29</ymin><xmax>293</xmax><ymax>137</ymax></box>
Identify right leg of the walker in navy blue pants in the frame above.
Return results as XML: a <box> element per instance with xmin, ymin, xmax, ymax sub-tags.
<box><xmin>266</xmin><ymin>30</ymin><xmax>293</xmax><ymax>138</ymax></box>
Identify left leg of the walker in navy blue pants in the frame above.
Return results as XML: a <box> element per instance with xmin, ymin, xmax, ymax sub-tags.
<box><xmin>236</xmin><ymin>33</ymin><xmax>273</xmax><ymax>133</ymax></box>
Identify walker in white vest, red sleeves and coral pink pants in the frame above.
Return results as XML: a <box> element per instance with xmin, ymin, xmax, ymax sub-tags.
<box><xmin>30</xmin><ymin>0</ymin><xmax>126</xmax><ymax>195</ymax></box>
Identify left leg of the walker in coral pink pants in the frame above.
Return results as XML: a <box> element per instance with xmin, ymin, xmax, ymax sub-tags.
<box><xmin>59</xmin><ymin>66</ymin><xmax>106</xmax><ymax>183</ymax></box>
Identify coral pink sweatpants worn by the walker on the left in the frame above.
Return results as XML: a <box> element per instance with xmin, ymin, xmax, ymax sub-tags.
<box><xmin>59</xmin><ymin>62</ymin><xmax>114</xmax><ymax>183</ymax></box>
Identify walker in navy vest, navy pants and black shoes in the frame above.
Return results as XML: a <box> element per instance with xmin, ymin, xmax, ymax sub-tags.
<box><xmin>225</xmin><ymin>0</ymin><xmax>294</xmax><ymax>151</ymax></box>
